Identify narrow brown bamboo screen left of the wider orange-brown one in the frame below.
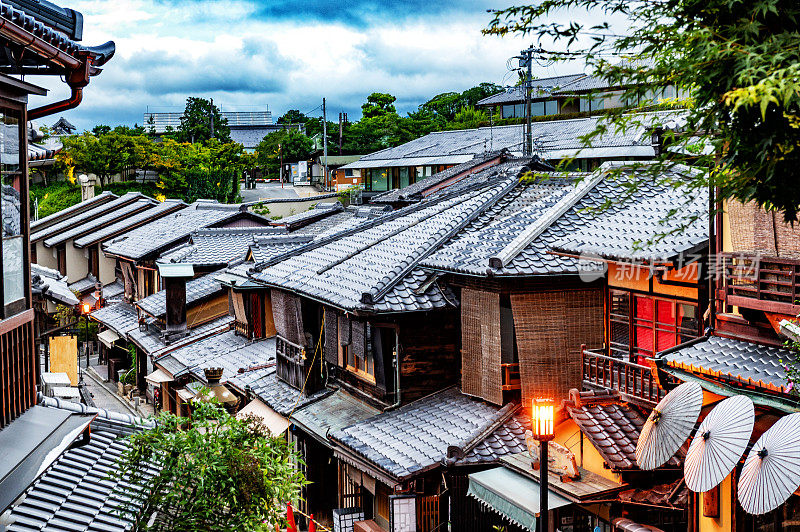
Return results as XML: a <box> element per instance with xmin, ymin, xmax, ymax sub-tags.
<box><xmin>461</xmin><ymin>288</ymin><xmax>503</xmax><ymax>405</ymax></box>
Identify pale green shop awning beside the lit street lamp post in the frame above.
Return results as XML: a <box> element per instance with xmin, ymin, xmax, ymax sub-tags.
<box><xmin>467</xmin><ymin>467</ymin><xmax>572</xmax><ymax>532</ymax></box>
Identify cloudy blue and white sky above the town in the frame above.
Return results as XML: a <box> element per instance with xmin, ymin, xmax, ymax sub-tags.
<box><xmin>31</xmin><ymin>0</ymin><xmax>592</xmax><ymax>130</ymax></box>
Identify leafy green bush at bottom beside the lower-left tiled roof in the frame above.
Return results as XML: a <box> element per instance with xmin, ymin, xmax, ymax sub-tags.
<box><xmin>117</xmin><ymin>393</ymin><xmax>306</xmax><ymax>532</ymax></box>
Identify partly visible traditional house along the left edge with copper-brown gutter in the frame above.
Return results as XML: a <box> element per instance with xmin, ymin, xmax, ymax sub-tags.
<box><xmin>0</xmin><ymin>2</ymin><xmax>161</xmax><ymax>530</ymax></box>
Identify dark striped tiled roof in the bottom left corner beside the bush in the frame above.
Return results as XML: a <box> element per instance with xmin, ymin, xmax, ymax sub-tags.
<box><xmin>4</xmin><ymin>398</ymin><xmax>155</xmax><ymax>532</ymax></box>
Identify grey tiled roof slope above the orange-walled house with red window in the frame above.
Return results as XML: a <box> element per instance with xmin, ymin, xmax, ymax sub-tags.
<box><xmin>553</xmin><ymin>165</ymin><xmax>708</xmax><ymax>262</ymax></box>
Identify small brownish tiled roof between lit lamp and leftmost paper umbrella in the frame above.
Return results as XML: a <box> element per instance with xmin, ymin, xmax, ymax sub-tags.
<box><xmin>567</xmin><ymin>392</ymin><xmax>681</xmax><ymax>470</ymax></box>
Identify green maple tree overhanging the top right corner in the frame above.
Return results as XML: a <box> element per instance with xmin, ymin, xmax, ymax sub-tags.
<box><xmin>485</xmin><ymin>0</ymin><xmax>800</xmax><ymax>221</ymax></box>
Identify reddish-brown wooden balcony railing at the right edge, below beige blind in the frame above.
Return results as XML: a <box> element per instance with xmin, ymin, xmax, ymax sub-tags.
<box><xmin>720</xmin><ymin>253</ymin><xmax>800</xmax><ymax>316</ymax></box>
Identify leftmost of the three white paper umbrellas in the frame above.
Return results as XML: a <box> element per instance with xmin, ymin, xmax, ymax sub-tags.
<box><xmin>636</xmin><ymin>382</ymin><xmax>703</xmax><ymax>470</ymax></box>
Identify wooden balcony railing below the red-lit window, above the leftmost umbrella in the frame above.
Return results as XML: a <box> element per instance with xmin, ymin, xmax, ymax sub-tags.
<box><xmin>583</xmin><ymin>349</ymin><xmax>666</xmax><ymax>405</ymax></box>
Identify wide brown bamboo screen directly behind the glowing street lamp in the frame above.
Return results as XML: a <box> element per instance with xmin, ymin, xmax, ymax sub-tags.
<box><xmin>511</xmin><ymin>289</ymin><xmax>603</xmax><ymax>405</ymax></box>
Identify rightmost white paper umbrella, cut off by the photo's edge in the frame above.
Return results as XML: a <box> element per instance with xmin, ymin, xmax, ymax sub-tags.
<box><xmin>739</xmin><ymin>413</ymin><xmax>800</xmax><ymax>515</ymax></box>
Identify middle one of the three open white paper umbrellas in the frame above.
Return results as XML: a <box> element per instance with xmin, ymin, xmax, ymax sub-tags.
<box><xmin>683</xmin><ymin>395</ymin><xmax>756</xmax><ymax>492</ymax></box>
